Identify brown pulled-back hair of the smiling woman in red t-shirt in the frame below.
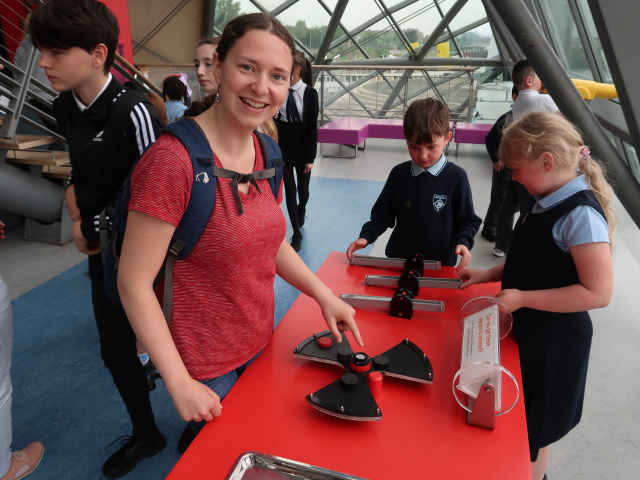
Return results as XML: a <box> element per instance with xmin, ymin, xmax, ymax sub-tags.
<box><xmin>216</xmin><ymin>13</ymin><xmax>296</xmax><ymax>68</ymax></box>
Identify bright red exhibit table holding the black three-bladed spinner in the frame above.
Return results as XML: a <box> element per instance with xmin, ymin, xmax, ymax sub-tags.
<box><xmin>167</xmin><ymin>252</ymin><xmax>531</xmax><ymax>480</ymax></box>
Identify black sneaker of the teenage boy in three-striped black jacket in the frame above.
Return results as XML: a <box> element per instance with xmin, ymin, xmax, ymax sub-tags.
<box><xmin>102</xmin><ymin>433</ymin><xmax>167</xmax><ymax>478</ymax></box>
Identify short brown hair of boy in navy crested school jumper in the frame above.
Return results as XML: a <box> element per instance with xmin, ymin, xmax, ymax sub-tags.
<box><xmin>402</xmin><ymin>98</ymin><xmax>450</xmax><ymax>144</ymax></box>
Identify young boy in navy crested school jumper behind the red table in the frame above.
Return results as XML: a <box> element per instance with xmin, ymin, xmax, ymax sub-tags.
<box><xmin>347</xmin><ymin>98</ymin><xmax>482</xmax><ymax>270</ymax></box>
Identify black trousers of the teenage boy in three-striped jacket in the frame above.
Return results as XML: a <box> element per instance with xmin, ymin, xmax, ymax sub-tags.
<box><xmin>89</xmin><ymin>254</ymin><xmax>159</xmax><ymax>437</ymax></box>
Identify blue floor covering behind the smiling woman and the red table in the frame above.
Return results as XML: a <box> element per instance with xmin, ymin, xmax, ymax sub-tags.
<box><xmin>12</xmin><ymin>177</ymin><xmax>383</xmax><ymax>480</ymax></box>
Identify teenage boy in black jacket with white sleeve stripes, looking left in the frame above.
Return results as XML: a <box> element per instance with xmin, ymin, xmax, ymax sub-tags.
<box><xmin>29</xmin><ymin>0</ymin><xmax>166</xmax><ymax>478</ymax></box>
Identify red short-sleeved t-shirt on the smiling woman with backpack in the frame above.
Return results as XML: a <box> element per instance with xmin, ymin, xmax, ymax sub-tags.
<box><xmin>129</xmin><ymin>135</ymin><xmax>286</xmax><ymax>380</ymax></box>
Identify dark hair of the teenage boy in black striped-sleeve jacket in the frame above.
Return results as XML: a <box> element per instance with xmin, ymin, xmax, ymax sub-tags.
<box><xmin>29</xmin><ymin>0</ymin><xmax>120</xmax><ymax>74</ymax></box>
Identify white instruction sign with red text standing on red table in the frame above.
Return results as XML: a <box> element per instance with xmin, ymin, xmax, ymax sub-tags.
<box><xmin>458</xmin><ymin>305</ymin><xmax>502</xmax><ymax>410</ymax></box>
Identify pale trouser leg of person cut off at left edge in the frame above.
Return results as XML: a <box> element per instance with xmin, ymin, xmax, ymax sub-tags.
<box><xmin>0</xmin><ymin>276</ymin><xmax>13</xmax><ymax>477</ymax></box>
